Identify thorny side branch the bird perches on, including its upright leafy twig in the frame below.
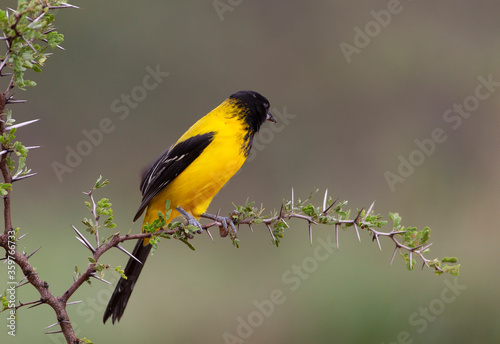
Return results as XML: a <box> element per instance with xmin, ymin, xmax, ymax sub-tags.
<box><xmin>67</xmin><ymin>183</ymin><xmax>459</xmax><ymax>312</ymax></box>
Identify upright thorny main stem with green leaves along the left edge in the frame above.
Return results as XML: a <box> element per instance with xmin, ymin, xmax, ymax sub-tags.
<box><xmin>0</xmin><ymin>0</ymin><xmax>80</xmax><ymax>343</ymax></box>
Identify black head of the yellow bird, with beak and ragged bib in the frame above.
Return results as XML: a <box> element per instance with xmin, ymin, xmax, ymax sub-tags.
<box><xmin>229</xmin><ymin>91</ymin><xmax>276</xmax><ymax>156</ymax></box>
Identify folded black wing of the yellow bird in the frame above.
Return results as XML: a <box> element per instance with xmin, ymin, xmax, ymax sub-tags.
<box><xmin>134</xmin><ymin>132</ymin><xmax>215</xmax><ymax>221</ymax></box>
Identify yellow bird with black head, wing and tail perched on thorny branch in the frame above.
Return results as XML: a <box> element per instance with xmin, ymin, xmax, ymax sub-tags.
<box><xmin>103</xmin><ymin>91</ymin><xmax>276</xmax><ymax>324</ymax></box>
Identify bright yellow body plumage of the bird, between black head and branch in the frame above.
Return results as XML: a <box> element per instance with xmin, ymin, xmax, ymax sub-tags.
<box><xmin>143</xmin><ymin>101</ymin><xmax>247</xmax><ymax>228</ymax></box>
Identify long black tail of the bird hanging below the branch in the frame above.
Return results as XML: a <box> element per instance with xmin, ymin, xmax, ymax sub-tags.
<box><xmin>102</xmin><ymin>240</ymin><xmax>151</xmax><ymax>324</ymax></box>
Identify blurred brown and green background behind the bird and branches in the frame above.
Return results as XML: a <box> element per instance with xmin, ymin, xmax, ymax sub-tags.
<box><xmin>0</xmin><ymin>0</ymin><xmax>500</xmax><ymax>344</ymax></box>
